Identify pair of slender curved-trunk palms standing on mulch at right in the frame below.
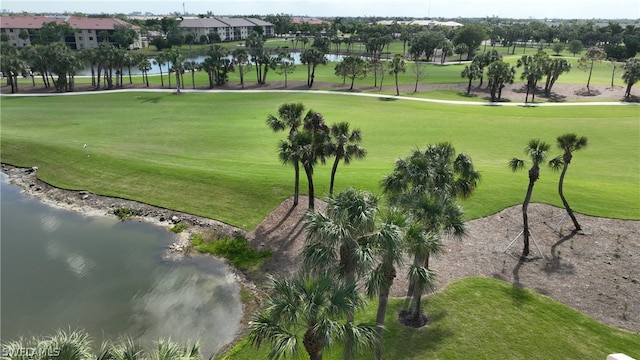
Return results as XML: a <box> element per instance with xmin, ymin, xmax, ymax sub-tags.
<box><xmin>509</xmin><ymin>133</ymin><xmax>589</xmax><ymax>258</ymax></box>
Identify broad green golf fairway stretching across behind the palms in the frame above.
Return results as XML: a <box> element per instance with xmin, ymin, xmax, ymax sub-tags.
<box><xmin>0</xmin><ymin>92</ymin><xmax>640</xmax><ymax>230</ymax></box>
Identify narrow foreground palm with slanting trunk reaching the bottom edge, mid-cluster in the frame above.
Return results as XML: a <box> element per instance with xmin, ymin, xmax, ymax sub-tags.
<box><xmin>367</xmin><ymin>209</ymin><xmax>407</xmax><ymax>360</ymax></box>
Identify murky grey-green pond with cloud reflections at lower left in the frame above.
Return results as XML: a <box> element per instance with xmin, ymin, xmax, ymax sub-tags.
<box><xmin>0</xmin><ymin>173</ymin><xmax>242</xmax><ymax>358</ymax></box>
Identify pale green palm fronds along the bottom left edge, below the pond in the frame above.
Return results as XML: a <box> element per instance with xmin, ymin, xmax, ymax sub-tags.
<box><xmin>2</xmin><ymin>330</ymin><xmax>201</xmax><ymax>360</ymax></box>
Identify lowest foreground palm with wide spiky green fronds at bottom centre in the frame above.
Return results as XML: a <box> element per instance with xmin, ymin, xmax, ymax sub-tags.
<box><xmin>249</xmin><ymin>273</ymin><xmax>376</xmax><ymax>360</ymax></box>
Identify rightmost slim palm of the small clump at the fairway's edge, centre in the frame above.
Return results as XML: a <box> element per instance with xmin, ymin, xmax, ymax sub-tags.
<box><xmin>329</xmin><ymin>122</ymin><xmax>367</xmax><ymax>196</ymax></box>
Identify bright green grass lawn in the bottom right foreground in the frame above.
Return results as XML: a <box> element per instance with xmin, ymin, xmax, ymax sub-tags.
<box><xmin>223</xmin><ymin>277</ymin><xmax>640</xmax><ymax>360</ymax></box>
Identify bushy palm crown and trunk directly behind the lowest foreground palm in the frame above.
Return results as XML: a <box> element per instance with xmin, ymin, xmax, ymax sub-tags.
<box><xmin>302</xmin><ymin>188</ymin><xmax>378</xmax><ymax>358</ymax></box>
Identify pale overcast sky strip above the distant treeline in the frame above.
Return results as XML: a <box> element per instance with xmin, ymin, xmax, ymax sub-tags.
<box><xmin>0</xmin><ymin>0</ymin><xmax>640</xmax><ymax>19</ymax></box>
